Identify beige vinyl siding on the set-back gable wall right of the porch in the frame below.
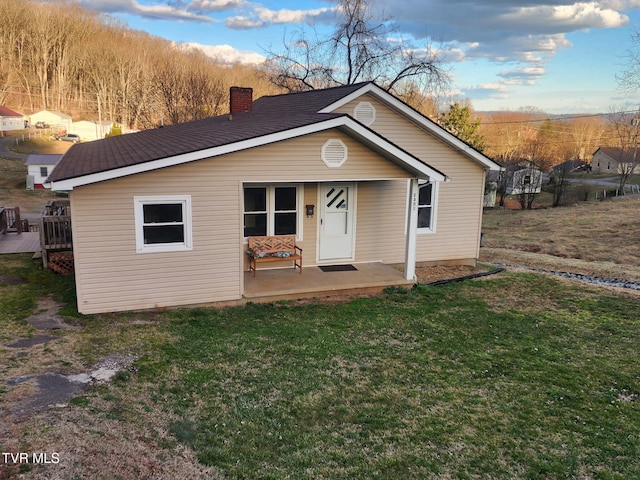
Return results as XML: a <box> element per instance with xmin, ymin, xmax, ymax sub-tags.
<box><xmin>338</xmin><ymin>95</ymin><xmax>484</xmax><ymax>262</ymax></box>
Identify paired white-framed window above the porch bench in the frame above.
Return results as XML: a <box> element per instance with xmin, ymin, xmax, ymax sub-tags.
<box><xmin>244</xmin><ymin>185</ymin><xmax>302</xmax><ymax>237</ymax></box>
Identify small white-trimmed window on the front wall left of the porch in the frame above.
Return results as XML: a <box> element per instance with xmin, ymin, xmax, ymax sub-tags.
<box><xmin>134</xmin><ymin>195</ymin><xmax>192</xmax><ymax>253</ymax></box>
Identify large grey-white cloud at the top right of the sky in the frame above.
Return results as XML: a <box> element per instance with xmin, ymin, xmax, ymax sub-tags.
<box><xmin>378</xmin><ymin>0</ymin><xmax>640</xmax><ymax>68</ymax></box>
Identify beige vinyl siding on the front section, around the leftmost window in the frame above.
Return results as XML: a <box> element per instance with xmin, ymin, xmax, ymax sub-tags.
<box><xmin>71</xmin><ymin>130</ymin><xmax>407</xmax><ymax>314</ymax></box>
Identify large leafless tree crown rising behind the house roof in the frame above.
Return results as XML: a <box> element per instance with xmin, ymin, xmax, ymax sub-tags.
<box><xmin>266</xmin><ymin>0</ymin><xmax>449</xmax><ymax>93</ymax></box>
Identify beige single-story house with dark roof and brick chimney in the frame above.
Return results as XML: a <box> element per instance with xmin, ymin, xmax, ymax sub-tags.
<box><xmin>49</xmin><ymin>82</ymin><xmax>500</xmax><ymax>314</ymax></box>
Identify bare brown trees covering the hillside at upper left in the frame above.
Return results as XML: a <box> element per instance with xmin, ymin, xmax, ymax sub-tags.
<box><xmin>0</xmin><ymin>0</ymin><xmax>278</xmax><ymax>129</ymax></box>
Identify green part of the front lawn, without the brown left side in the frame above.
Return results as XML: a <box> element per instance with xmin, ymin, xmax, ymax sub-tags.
<box><xmin>131</xmin><ymin>275</ymin><xmax>640</xmax><ymax>479</ymax></box>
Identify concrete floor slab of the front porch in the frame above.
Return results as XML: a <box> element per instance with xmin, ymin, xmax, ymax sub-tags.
<box><xmin>243</xmin><ymin>262</ymin><xmax>413</xmax><ymax>302</ymax></box>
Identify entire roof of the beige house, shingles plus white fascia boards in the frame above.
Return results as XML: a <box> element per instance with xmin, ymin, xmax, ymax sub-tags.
<box><xmin>49</xmin><ymin>83</ymin><xmax>499</xmax><ymax>190</ymax></box>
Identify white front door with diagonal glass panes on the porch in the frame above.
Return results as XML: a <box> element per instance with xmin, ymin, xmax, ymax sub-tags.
<box><xmin>318</xmin><ymin>183</ymin><xmax>355</xmax><ymax>262</ymax></box>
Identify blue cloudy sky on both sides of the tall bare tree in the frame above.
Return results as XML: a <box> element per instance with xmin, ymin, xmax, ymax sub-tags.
<box><xmin>75</xmin><ymin>0</ymin><xmax>640</xmax><ymax>113</ymax></box>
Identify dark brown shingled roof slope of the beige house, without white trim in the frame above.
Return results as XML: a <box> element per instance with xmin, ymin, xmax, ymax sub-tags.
<box><xmin>49</xmin><ymin>82</ymin><xmax>436</xmax><ymax>182</ymax></box>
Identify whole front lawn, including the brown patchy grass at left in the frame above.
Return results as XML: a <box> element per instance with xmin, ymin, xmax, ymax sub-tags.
<box><xmin>0</xmin><ymin>256</ymin><xmax>640</xmax><ymax>479</ymax></box>
